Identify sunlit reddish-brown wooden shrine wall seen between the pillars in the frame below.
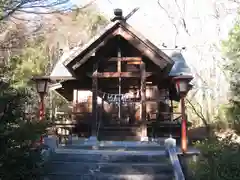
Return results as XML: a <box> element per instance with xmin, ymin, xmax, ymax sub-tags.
<box><xmin>72</xmin><ymin>86</ymin><xmax>171</xmax><ymax>123</ymax></box>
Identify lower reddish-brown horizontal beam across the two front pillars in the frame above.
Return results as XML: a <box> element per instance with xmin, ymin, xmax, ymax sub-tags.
<box><xmin>87</xmin><ymin>72</ymin><xmax>153</xmax><ymax>78</ymax></box>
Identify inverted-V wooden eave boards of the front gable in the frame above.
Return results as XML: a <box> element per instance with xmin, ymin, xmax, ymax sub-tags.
<box><xmin>63</xmin><ymin>21</ymin><xmax>174</xmax><ymax>72</ymax></box>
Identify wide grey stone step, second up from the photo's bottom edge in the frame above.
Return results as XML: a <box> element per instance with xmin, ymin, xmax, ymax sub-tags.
<box><xmin>45</xmin><ymin>161</ymin><xmax>173</xmax><ymax>174</ymax></box>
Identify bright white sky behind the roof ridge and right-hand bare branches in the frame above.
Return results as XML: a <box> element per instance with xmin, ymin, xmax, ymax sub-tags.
<box><xmin>51</xmin><ymin>0</ymin><xmax>239</xmax><ymax>102</ymax></box>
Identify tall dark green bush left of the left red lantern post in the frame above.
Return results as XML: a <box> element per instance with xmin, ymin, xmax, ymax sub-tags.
<box><xmin>0</xmin><ymin>86</ymin><xmax>46</xmax><ymax>180</ymax></box>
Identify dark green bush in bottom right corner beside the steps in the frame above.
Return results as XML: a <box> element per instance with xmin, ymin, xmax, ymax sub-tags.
<box><xmin>191</xmin><ymin>137</ymin><xmax>240</xmax><ymax>180</ymax></box>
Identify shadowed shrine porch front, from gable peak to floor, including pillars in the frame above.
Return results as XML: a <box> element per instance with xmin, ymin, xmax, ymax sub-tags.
<box><xmin>89</xmin><ymin>35</ymin><xmax>160</xmax><ymax>137</ymax></box>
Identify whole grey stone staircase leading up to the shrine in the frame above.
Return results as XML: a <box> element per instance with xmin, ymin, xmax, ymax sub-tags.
<box><xmin>45</xmin><ymin>142</ymin><xmax>174</xmax><ymax>180</ymax></box>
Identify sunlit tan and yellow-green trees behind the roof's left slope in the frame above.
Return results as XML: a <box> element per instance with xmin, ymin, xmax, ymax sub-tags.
<box><xmin>0</xmin><ymin>5</ymin><xmax>107</xmax><ymax>87</ymax></box>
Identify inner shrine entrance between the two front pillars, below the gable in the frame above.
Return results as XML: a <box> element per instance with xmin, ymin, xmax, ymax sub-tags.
<box><xmin>96</xmin><ymin>55</ymin><xmax>146</xmax><ymax>125</ymax></box>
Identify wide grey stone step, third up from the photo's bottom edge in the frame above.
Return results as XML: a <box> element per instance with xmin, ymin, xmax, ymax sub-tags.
<box><xmin>52</xmin><ymin>149</ymin><xmax>169</xmax><ymax>163</ymax></box>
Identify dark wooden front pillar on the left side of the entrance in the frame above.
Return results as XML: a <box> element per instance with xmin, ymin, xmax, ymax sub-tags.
<box><xmin>91</xmin><ymin>64</ymin><xmax>98</xmax><ymax>137</ymax></box>
